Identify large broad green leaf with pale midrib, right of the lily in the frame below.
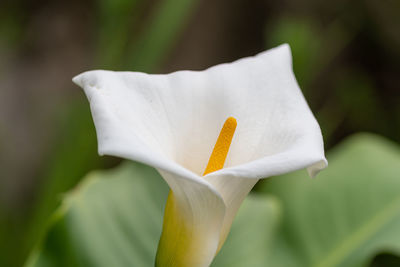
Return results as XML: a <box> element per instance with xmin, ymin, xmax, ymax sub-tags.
<box><xmin>260</xmin><ymin>134</ymin><xmax>400</xmax><ymax>267</ymax></box>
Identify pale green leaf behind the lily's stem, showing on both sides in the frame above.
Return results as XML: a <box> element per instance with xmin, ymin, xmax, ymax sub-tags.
<box><xmin>26</xmin><ymin>162</ymin><xmax>279</xmax><ymax>267</ymax></box>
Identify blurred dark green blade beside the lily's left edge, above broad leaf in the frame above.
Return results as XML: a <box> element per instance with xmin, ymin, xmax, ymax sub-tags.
<box><xmin>19</xmin><ymin>102</ymin><xmax>104</xmax><ymax>262</ymax></box>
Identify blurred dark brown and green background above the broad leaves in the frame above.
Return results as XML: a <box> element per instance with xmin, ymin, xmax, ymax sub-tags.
<box><xmin>0</xmin><ymin>0</ymin><xmax>400</xmax><ymax>266</ymax></box>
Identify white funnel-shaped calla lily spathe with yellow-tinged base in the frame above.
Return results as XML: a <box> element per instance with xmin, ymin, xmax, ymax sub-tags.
<box><xmin>73</xmin><ymin>45</ymin><xmax>327</xmax><ymax>267</ymax></box>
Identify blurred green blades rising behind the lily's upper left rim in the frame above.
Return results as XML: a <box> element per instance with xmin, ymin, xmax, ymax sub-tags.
<box><xmin>97</xmin><ymin>0</ymin><xmax>197</xmax><ymax>72</ymax></box>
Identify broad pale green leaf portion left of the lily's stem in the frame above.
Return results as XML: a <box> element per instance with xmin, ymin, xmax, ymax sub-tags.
<box><xmin>27</xmin><ymin>163</ymin><xmax>168</xmax><ymax>267</ymax></box>
